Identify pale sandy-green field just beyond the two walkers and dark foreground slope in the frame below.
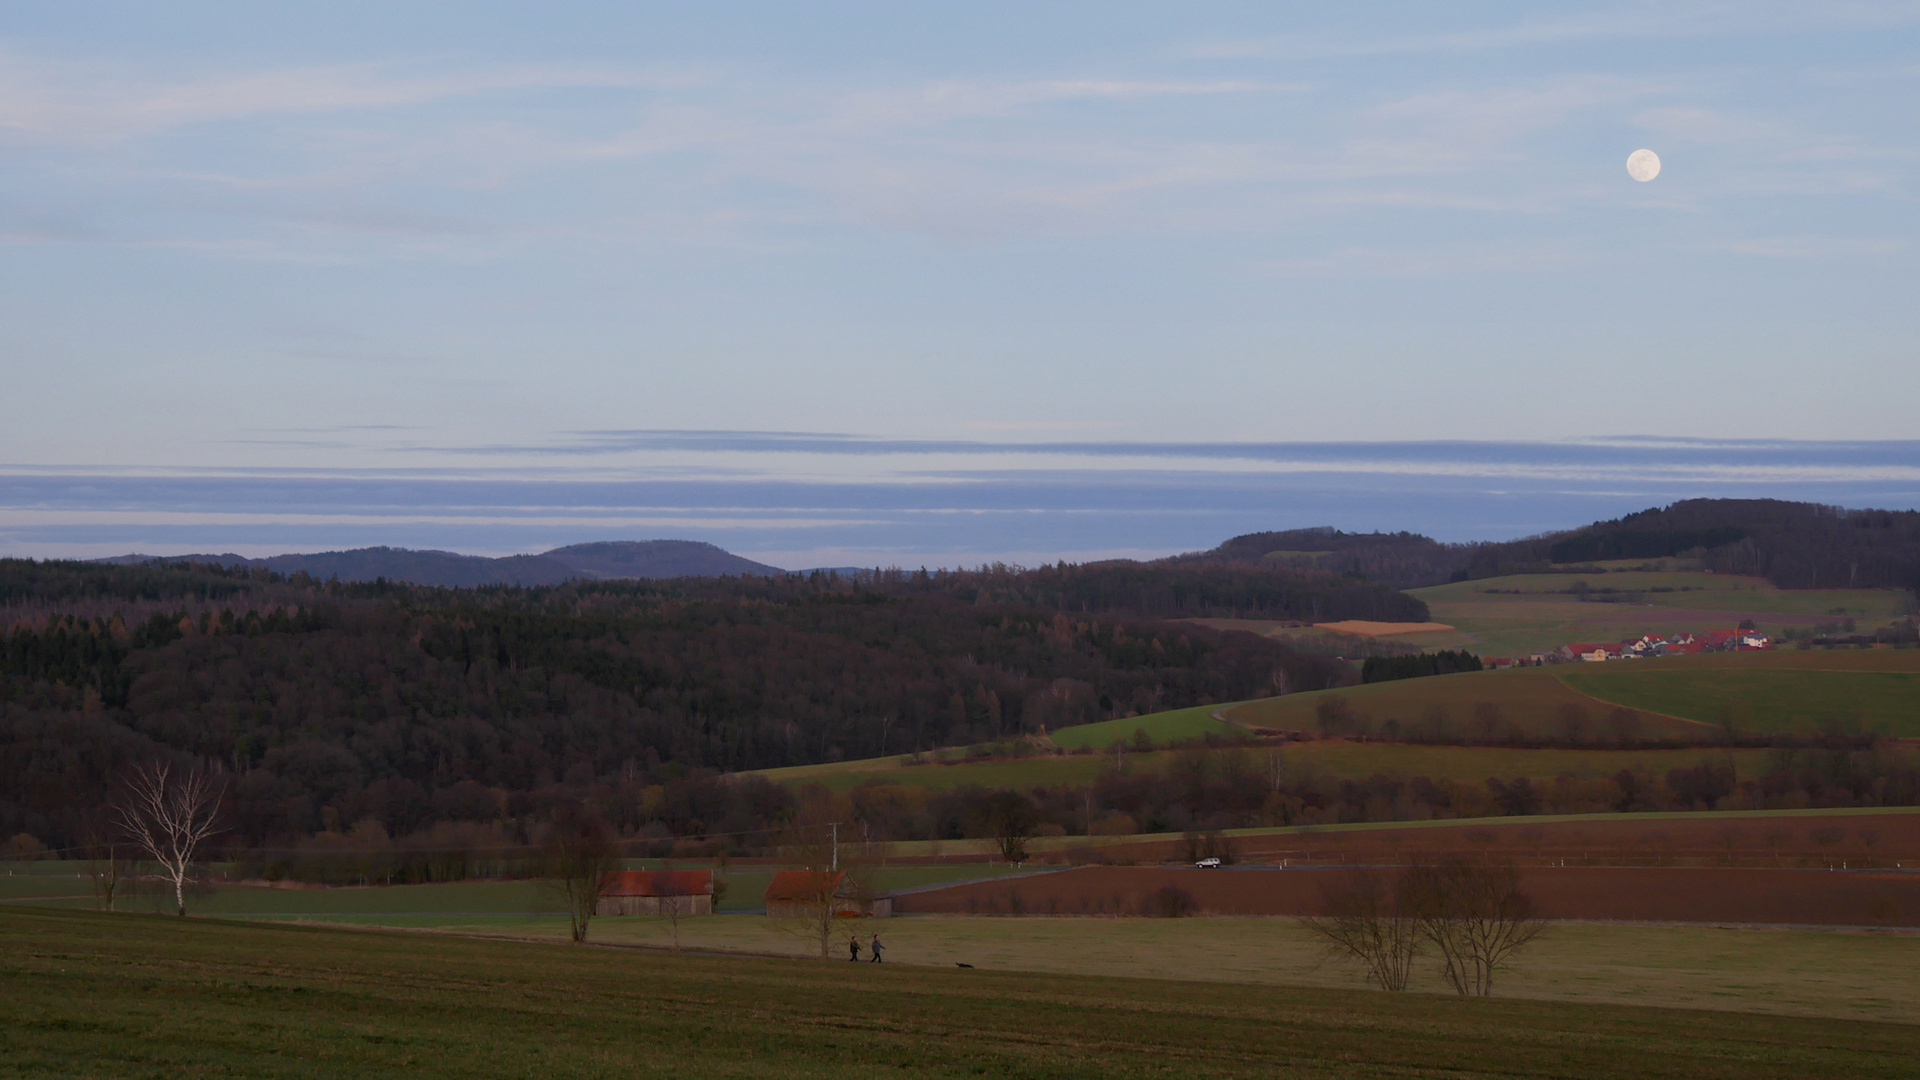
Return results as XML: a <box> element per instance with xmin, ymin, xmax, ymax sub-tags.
<box><xmin>397</xmin><ymin>915</ymin><xmax>1920</xmax><ymax>1019</ymax></box>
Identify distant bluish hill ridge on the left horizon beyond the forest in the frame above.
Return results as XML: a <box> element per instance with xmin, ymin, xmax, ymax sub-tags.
<box><xmin>100</xmin><ymin>540</ymin><xmax>787</xmax><ymax>588</ymax></box>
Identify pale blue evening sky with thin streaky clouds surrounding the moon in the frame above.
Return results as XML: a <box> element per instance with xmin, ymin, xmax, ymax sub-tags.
<box><xmin>0</xmin><ymin>0</ymin><xmax>1920</xmax><ymax>565</ymax></box>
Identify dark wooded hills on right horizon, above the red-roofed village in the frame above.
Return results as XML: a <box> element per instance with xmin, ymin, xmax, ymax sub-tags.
<box><xmin>1179</xmin><ymin>500</ymin><xmax>1920</xmax><ymax>590</ymax></box>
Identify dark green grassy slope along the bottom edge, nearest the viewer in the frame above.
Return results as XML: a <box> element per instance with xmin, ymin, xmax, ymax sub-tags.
<box><xmin>0</xmin><ymin>911</ymin><xmax>1920</xmax><ymax>1080</ymax></box>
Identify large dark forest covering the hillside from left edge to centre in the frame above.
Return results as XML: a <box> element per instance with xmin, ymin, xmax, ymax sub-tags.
<box><xmin>0</xmin><ymin>561</ymin><xmax>1374</xmax><ymax>844</ymax></box>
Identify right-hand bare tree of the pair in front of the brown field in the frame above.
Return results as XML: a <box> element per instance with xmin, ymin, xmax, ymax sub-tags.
<box><xmin>1405</xmin><ymin>857</ymin><xmax>1546</xmax><ymax>997</ymax></box>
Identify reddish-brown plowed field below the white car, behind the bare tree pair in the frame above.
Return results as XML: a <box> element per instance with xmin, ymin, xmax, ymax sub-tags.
<box><xmin>893</xmin><ymin>867</ymin><xmax>1920</xmax><ymax>926</ymax></box>
